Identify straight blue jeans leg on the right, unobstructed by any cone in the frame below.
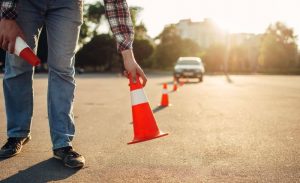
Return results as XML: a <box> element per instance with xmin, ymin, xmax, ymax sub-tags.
<box><xmin>45</xmin><ymin>0</ymin><xmax>82</xmax><ymax>149</ymax></box>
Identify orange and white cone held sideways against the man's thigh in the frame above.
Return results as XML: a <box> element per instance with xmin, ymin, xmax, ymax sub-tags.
<box><xmin>14</xmin><ymin>37</ymin><xmax>41</xmax><ymax>66</ymax></box>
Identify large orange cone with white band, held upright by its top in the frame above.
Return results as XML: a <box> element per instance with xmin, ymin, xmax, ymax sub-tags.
<box><xmin>128</xmin><ymin>73</ymin><xmax>168</xmax><ymax>144</ymax></box>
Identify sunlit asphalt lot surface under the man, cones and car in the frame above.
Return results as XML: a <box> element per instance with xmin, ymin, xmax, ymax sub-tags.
<box><xmin>0</xmin><ymin>75</ymin><xmax>300</xmax><ymax>183</ymax></box>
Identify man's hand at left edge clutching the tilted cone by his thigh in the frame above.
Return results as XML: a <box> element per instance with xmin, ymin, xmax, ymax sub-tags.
<box><xmin>0</xmin><ymin>19</ymin><xmax>24</xmax><ymax>53</ymax></box>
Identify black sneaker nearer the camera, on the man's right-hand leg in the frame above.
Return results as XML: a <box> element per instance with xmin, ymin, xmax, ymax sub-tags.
<box><xmin>53</xmin><ymin>146</ymin><xmax>85</xmax><ymax>168</ymax></box>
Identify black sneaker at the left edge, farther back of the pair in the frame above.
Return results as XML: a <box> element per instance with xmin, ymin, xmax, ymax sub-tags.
<box><xmin>0</xmin><ymin>136</ymin><xmax>30</xmax><ymax>158</ymax></box>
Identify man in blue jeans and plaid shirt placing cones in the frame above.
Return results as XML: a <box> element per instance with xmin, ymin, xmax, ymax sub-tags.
<box><xmin>0</xmin><ymin>0</ymin><xmax>147</xmax><ymax>168</ymax></box>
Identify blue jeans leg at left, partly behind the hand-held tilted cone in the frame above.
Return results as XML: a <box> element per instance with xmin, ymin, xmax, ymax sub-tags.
<box><xmin>3</xmin><ymin>1</ymin><xmax>43</xmax><ymax>137</ymax></box>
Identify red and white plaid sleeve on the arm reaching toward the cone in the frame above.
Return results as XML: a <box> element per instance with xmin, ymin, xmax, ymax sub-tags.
<box><xmin>104</xmin><ymin>0</ymin><xmax>134</xmax><ymax>52</ymax></box>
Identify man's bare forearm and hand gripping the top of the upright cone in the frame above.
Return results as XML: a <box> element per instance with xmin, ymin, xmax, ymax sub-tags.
<box><xmin>122</xmin><ymin>49</ymin><xmax>147</xmax><ymax>86</ymax></box>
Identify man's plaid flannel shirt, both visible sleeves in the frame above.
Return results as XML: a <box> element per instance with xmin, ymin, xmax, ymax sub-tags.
<box><xmin>0</xmin><ymin>0</ymin><xmax>134</xmax><ymax>52</ymax></box>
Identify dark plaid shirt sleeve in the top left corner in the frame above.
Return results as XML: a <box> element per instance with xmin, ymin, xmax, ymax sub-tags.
<box><xmin>0</xmin><ymin>0</ymin><xmax>18</xmax><ymax>20</ymax></box>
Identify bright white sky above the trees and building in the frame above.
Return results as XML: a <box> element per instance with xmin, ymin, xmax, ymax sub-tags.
<box><xmin>86</xmin><ymin>0</ymin><xmax>300</xmax><ymax>42</ymax></box>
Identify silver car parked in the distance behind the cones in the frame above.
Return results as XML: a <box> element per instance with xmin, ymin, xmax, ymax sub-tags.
<box><xmin>174</xmin><ymin>57</ymin><xmax>205</xmax><ymax>82</ymax></box>
